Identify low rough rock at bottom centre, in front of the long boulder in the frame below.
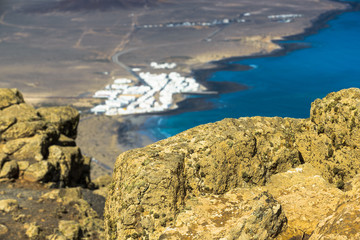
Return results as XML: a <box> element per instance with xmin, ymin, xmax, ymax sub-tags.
<box><xmin>160</xmin><ymin>189</ymin><xmax>287</xmax><ymax>240</ymax></box>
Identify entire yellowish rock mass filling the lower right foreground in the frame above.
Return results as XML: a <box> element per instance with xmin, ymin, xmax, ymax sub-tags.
<box><xmin>105</xmin><ymin>88</ymin><xmax>360</xmax><ymax>240</ymax></box>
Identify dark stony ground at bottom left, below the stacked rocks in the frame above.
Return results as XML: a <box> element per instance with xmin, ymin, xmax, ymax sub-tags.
<box><xmin>0</xmin><ymin>179</ymin><xmax>105</xmax><ymax>240</ymax></box>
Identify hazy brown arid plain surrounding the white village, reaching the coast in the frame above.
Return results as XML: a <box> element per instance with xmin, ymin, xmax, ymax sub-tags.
<box><xmin>0</xmin><ymin>0</ymin><xmax>346</xmax><ymax>175</ymax></box>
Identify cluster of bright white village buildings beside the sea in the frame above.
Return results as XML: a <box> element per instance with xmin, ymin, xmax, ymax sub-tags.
<box><xmin>90</xmin><ymin>62</ymin><xmax>205</xmax><ymax>115</ymax></box>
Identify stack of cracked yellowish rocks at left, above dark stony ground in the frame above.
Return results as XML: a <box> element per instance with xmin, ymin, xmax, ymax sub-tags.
<box><xmin>0</xmin><ymin>89</ymin><xmax>90</xmax><ymax>187</ymax></box>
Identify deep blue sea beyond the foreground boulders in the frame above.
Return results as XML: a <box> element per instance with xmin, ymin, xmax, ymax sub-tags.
<box><xmin>144</xmin><ymin>0</ymin><xmax>360</xmax><ymax>140</ymax></box>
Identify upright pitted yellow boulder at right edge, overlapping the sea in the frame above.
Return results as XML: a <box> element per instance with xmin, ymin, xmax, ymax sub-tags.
<box><xmin>296</xmin><ymin>88</ymin><xmax>360</xmax><ymax>188</ymax></box>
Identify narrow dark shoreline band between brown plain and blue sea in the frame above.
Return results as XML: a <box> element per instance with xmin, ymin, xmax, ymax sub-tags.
<box><xmin>134</xmin><ymin>0</ymin><xmax>354</xmax><ymax>142</ymax></box>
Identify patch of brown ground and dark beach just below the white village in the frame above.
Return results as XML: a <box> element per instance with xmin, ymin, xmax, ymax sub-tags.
<box><xmin>76</xmin><ymin>115</ymin><xmax>152</xmax><ymax>178</ymax></box>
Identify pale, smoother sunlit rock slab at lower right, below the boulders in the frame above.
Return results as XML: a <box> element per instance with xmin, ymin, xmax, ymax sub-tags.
<box><xmin>261</xmin><ymin>163</ymin><xmax>344</xmax><ymax>240</ymax></box>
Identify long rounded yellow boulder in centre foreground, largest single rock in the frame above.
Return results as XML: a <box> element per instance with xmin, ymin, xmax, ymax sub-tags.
<box><xmin>106</xmin><ymin>117</ymin><xmax>303</xmax><ymax>239</ymax></box>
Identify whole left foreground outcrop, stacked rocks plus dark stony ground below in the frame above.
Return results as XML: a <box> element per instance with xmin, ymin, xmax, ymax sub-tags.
<box><xmin>0</xmin><ymin>89</ymin><xmax>108</xmax><ymax>240</ymax></box>
